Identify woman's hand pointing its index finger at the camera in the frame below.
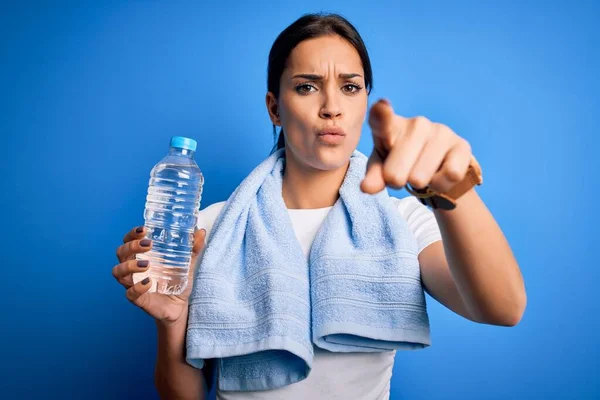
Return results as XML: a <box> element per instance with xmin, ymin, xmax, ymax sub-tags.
<box><xmin>361</xmin><ymin>100</ymin><xmax>471</xmax><ymax>194</ymax></box>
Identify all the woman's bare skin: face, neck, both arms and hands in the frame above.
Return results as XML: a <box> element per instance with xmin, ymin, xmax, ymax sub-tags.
<box><xmin>113</xmin><ymin>32</ymin><xmax>526</xmax><ymax>399</ymax></box>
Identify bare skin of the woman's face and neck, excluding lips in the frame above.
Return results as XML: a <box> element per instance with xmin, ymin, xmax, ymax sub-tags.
<box><xmin>267</xmin><ymin>36</ymin><xmax>367</xmax><ymax>208</ymax></box>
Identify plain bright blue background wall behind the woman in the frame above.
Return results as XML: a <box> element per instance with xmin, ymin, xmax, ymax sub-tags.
<box><xmin>0</xmin><ymin>1</ymin><xmax>600</xmax><ymax>399</ymax></box>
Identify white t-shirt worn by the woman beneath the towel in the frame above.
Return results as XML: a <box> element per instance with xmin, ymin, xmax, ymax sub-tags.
<box><xmin>198</xmin><ymin>197</ymin><xmax>442</xmax><ymax>400</ymax></box>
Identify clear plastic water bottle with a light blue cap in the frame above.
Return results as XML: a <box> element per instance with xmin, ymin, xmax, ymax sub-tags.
<box><xmin>133</xmin><ymin>136</ymin><xmax>204</xmax><ymax>295</ymax></box>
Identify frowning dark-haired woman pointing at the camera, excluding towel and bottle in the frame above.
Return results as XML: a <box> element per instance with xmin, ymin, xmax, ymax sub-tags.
<box><xmin>113</xmin><ymin>15</ymin><xmax>526</xmax><ymax>399</ymax></box>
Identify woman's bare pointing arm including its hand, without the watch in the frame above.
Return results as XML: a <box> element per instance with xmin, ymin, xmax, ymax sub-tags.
<box><xmin>361</xmin><ymin>101</ymin><xmax>527</xmax><ymax>326</ymax></box>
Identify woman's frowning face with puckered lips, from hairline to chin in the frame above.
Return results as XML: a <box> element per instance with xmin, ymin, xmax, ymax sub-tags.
<box><xmin>272</xmin><ymin>35</ymin><xmax>367</xmax><ymax>170</ymax></box>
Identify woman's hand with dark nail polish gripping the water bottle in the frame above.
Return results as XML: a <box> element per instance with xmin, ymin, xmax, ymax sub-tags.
<box><xmin>112</xmin><ymin>226</ymin><xmax>206</xmax><ymax>325</ymax></box>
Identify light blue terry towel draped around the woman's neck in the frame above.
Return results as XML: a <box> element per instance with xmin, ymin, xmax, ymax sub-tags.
<box><xmin>186</xmin><ymin>150</ymin><xmax>430</xmax><ymax>391</ymax></box>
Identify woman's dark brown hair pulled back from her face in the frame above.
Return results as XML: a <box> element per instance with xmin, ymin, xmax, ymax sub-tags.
<box><xmin>267</xmin><ymin>14</ymin><xmax>373</xmax><ymax>152</ymax></box>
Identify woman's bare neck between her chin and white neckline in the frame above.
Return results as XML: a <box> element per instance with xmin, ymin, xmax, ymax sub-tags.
<box><xmin>282</xmin><ymin>148</ymin><xmax>348</xmax><ymax>209</ymax></box>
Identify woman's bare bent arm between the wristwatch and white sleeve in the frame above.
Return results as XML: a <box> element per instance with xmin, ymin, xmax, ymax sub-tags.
<box><xmin>419</xmin><ymin>190</ymin><xmax>527</xmax><ymax>326</ymax></box>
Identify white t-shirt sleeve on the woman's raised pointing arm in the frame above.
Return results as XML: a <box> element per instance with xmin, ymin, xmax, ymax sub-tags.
<box><xmin>392</xmin><ymin>196</ymin><xmax>442</xmax><ymax>253</ymax></box>
